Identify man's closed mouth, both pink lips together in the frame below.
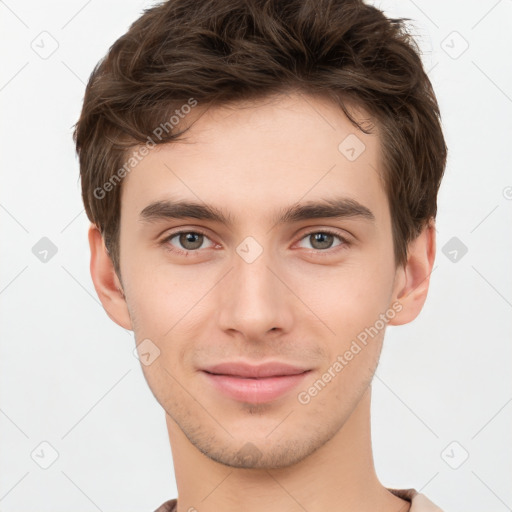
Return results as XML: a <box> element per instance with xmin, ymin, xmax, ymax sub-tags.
<box><xmin>202</xmin><ymin>362</ymin><xmax>311</xmax><ymax>404</ymax></box>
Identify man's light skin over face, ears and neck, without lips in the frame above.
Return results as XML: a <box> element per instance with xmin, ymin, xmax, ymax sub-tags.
<box><xmin>89</xmin><ymin>94</ymin><xmax>435</xmax><ymax>512</ymax></box>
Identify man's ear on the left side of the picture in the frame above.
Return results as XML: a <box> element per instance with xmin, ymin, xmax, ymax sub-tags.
<box><xmin>89</xmin><ymin>224</ymin><xmax>133</xmax><ymax>331</ymax></box>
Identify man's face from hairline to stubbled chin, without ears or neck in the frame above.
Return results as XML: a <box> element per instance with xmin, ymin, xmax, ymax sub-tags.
<box><xmin>120</xmin><ymin>95</ymin><xmax>402</xmax><ymax>467</ymax></box>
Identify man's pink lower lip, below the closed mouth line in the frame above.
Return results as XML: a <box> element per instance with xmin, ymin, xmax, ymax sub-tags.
<box><xmin>203</xmin><ymin>371</ymin><xmax>310</xmax><ymax>404</ymax></box>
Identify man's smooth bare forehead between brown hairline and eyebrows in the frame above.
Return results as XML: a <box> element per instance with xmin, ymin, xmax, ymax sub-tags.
<box><xmin>121</xmin><ymin>94</ymin><xmax>387</xmax><ymax>228</ymax></box>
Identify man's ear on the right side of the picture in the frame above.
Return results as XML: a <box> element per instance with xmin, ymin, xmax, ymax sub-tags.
<box><xmin>389</xmin><ymin>219</ymin><xmax>436</xmax><ymax>325</ymax></box>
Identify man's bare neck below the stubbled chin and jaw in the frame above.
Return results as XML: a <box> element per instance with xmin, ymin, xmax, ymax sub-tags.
<box><xmin>166</xmin><ymin>388</ymin><xmax>409</xmax><ymax>512</ymax></box>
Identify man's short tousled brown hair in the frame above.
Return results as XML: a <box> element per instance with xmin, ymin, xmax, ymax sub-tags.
<box><xmin>74</xmin><ymin>0</ymin><xmax>447</xmax><ymax>276</ymax></box>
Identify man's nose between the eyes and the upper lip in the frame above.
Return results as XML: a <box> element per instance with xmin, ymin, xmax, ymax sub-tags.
<box><xmin>218</xmin><ymin>242</ymin><xmax>294</xmax><ymax>341</ymax></box>
